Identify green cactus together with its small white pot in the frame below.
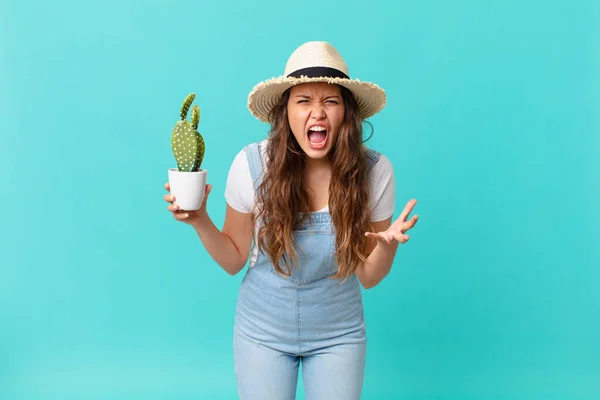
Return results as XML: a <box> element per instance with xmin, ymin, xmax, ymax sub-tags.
<box><xmin>169</xmin><ymin>93</ymin><xmax>207</xmax><ymax>211</ymax></box>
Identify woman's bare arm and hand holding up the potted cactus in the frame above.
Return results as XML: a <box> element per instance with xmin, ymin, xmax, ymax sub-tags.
<box><xmin>165</xmin><ymin>183</ymin><xmax>253</xmax><ymax>275</ymax></box>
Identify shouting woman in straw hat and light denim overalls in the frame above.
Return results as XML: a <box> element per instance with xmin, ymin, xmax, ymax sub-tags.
<box><xmin>165</xmin><ymin>42</ymin><xmax>417</xmax><ymax>400</ymax></box>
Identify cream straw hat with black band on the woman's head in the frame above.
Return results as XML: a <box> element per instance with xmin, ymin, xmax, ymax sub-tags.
<box><xmin>248</xmin><ymin>42</ymin><xmax>386</xmax><ymax>122</ymax></box>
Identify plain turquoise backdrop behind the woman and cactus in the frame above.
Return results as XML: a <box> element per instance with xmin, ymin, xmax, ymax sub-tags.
<box><xmin>0</xmin><ymin>0</ymin><xmax>600</xmax><ymax>400</ymax></box>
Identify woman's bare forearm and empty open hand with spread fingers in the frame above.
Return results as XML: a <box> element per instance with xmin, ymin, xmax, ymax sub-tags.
<box><xmin>356</xmin><ymin>199</ymin><xmax>419</xmax><ymax>289</ymax></box>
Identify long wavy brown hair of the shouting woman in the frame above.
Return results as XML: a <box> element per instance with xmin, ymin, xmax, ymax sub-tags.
<box><xmin>252</xmin><ymin>86</ymin><xmax>371</xmax><ymax>278</ymax></box>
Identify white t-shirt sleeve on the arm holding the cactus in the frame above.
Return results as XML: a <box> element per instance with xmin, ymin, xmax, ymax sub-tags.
<box><xmin>225</xmin><ymin>150</ymin><xmax>254</xmax><ymax>214</ymax></box>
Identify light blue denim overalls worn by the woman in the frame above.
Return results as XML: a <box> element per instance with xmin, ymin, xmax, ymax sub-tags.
<box><xmin>234</xmin><ymin>143</ymin><xmax>379</xmax><ymax>400</ymax></box>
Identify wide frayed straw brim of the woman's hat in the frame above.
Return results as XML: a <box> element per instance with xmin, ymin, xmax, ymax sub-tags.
<box><xmin>248</xmin><ymin>76</ymin><xmax>386</xmax><ymax>123</ymax></box>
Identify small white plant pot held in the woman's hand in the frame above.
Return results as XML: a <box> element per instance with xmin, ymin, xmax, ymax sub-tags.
<box><xmin>169</xmin><ymin>168</ymin><xmax>208</xmax><ymax>211</ymax></box>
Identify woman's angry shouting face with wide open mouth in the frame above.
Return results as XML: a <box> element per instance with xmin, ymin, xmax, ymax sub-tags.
<box><xmin>287</xmin><ymin>82</ymin><xmax>344</xmax><ymax>159</ymax></box>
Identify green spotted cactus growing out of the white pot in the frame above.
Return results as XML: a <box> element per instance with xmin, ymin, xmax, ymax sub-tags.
<box><xmin>171</xmin><ymin>93</ymin><xmax>204</xmax><ymax>172</ymax></box>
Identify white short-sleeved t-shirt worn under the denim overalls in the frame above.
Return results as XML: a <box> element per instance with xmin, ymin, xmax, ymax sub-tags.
<box><xmin>225</xmin><ymin>139</ymin><xmax>395</xmax><ymax>266</ymax></box>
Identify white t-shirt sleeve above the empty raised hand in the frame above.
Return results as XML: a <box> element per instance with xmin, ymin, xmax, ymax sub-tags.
<box><xmin>369</xmin><ymin>154</ymin><xmax>396</xmax><ymax>222</ymax></box>
